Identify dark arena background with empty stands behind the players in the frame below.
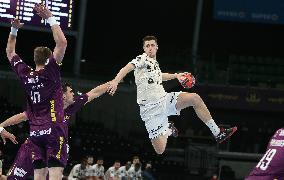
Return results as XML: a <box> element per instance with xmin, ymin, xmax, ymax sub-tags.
<box><xmin>0</xmin><ymin>0</ymin><xmax>284</xmax><ymax>180</ymax></box>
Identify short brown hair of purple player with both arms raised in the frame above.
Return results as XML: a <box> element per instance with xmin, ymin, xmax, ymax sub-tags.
<box><xmin>34</xmin><ymin>46</ymin><xmax>52</xmax><ymax>66</ymax></box>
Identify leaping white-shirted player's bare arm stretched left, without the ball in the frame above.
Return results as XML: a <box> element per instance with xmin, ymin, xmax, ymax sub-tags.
<box><xmin>108</xmin><ymin>63</ymin><xmax>135</xmax><ymax>95</ymax></box>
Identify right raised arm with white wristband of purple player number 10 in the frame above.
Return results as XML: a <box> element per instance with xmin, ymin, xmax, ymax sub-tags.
<box><xmin>34</xmin><ymin>4</ymin><xmax>67</xmax><ymax>64</ymax></box>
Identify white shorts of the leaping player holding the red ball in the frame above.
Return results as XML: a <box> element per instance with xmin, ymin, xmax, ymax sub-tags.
<box><xmin>140</xmin><ymin>92</ymin><xmax>181</xmax><ymax>139</ymax></box>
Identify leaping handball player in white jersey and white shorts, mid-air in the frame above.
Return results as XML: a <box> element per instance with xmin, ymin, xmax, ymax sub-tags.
<box><xmin>108</xmin><ymin>36</ymin><xmax>237</xmax><ymax>154</ymax></box>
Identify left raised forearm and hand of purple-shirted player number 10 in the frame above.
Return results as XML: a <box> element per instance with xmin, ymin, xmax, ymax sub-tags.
<box><xmin>6</xmin><ymin>19</ymin><xmax>24</xmax><ymax>61</ymax></box>
